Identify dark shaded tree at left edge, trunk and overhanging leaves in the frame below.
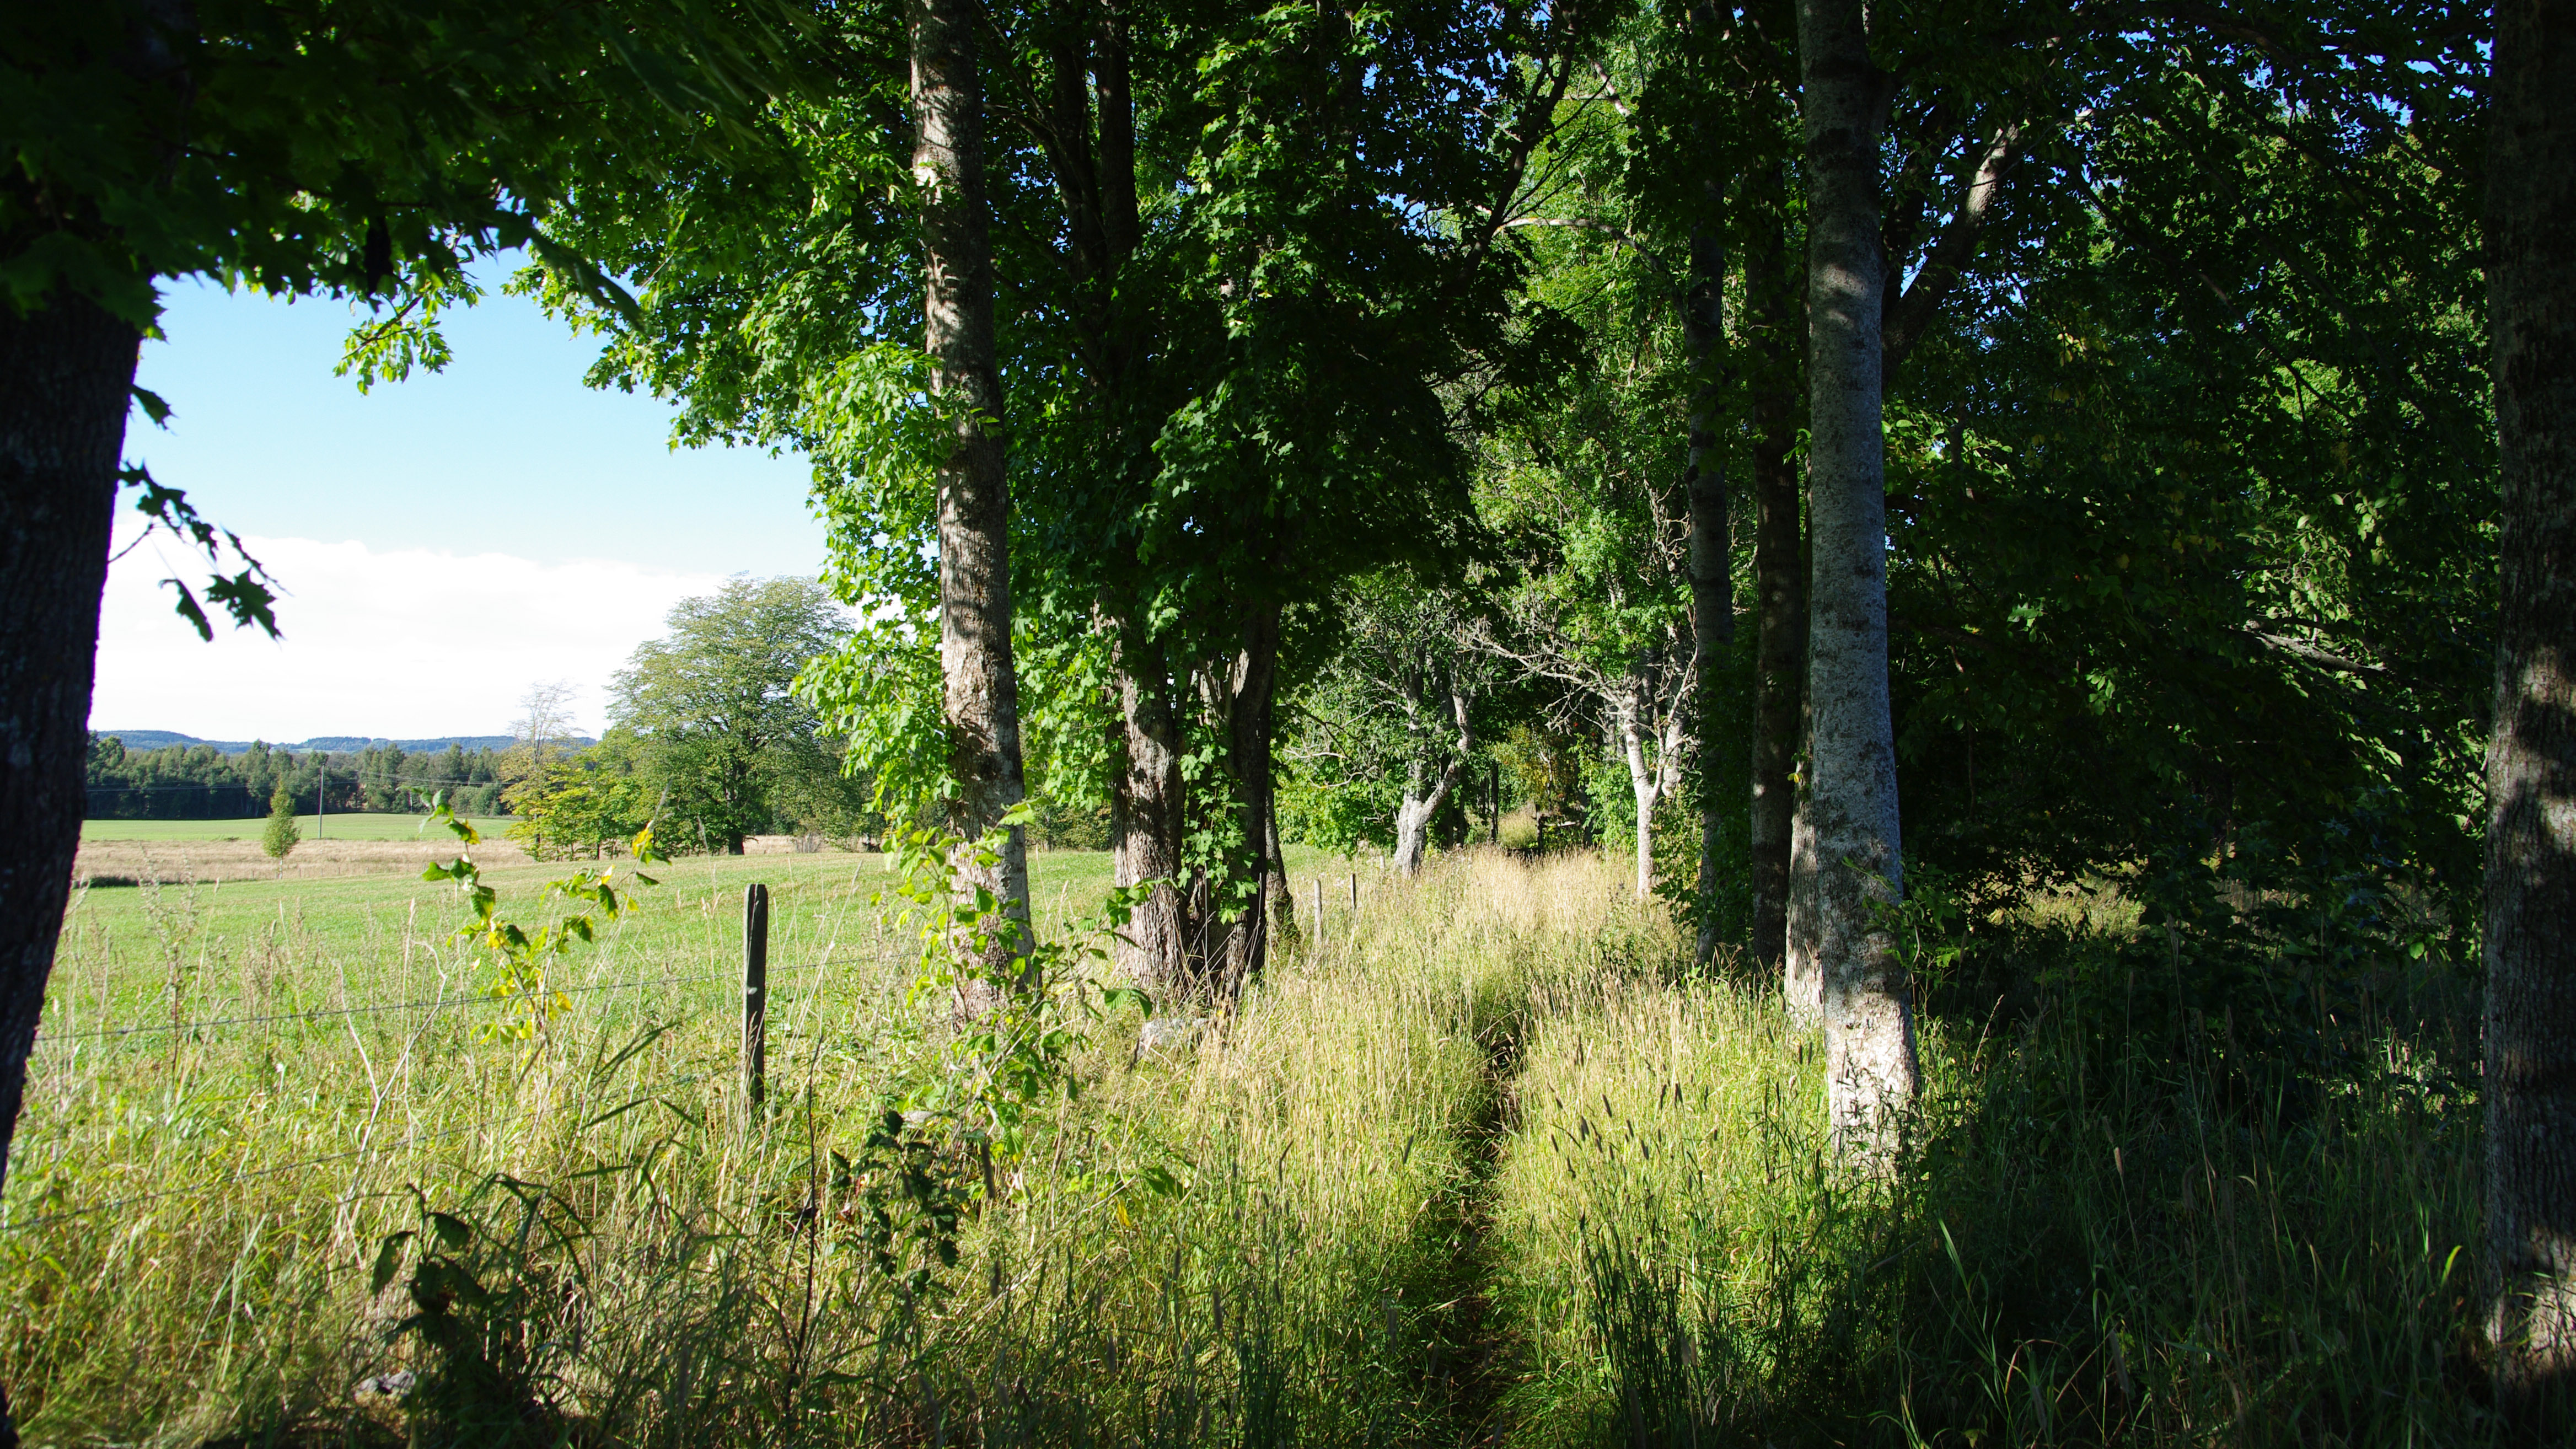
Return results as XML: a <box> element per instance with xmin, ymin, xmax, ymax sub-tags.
<box><xmin>0</xmin><ymin>0</ymin><xmax>783</xmax><ymax>1217</ymax></box>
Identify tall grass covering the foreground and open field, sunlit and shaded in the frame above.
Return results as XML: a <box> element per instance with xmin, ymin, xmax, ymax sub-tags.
<box><xmin>0</xmin><ymin>854</ymin><xmax>2491</xmax><ymax>1449</ymax></box>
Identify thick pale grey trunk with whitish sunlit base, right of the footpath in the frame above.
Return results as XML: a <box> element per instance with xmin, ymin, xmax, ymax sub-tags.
<box><xmin>1793</xmin><ymin>0</ymin><xmax>1917</xmax><ymax>1158</ymax></box>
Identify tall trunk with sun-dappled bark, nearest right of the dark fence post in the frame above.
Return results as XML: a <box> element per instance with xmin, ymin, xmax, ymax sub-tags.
<box><xmin>912</xmin><ymin>0</ymin><xmax>1031</xmax><ymax>949</ymax></box>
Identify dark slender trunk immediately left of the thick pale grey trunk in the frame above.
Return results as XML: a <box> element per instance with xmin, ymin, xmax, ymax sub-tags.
<box><xmin>1744</xmin><ymin>168</ymin><xmax>1818</xmax><ymax>990</ymax></box>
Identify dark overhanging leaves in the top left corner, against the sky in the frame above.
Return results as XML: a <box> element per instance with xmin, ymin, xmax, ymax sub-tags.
<box><xmin>0</xmin><ymin>0</ymin><xmax>801</xmax><ymax>637</ymax></box>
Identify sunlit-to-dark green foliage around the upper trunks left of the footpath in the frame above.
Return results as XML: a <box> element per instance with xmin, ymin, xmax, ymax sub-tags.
<box><xmin>530</xmin><ymin>3</ymin><xmax>1576</xmax><ymax>897</ymax></box>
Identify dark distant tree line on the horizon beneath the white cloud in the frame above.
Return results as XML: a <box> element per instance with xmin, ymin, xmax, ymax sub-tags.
<box><xmin>88</xmin><ymin>735</ymin><xmax>507</xmax><ymax>820</ymax></box>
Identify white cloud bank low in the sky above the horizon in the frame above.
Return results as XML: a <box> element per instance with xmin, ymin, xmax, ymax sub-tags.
<box><xmin>90</xmin><ymin>536</ymin><xmax>724</xmax><ymax>740</ymax></box>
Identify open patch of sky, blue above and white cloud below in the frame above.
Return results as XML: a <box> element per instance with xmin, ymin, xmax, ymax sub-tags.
<box><xmin>90</xmin><ymin>265</ymin><xmax>822</xmax><ymax>740</ymax></box>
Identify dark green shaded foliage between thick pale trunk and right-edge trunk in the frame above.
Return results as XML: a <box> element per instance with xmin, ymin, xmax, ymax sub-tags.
<box><xmin>1888</xmin><ymin>52</ymin><xmax>2493</xmax><ymax>928</ymax></box>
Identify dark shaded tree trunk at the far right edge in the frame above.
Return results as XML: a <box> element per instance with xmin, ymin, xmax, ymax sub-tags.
<box><xmin>2486</xmin><ymin>5</ymin><xmax>2576</xmax><ymax>1441</ymax></box>
